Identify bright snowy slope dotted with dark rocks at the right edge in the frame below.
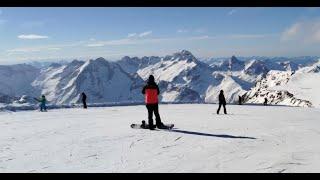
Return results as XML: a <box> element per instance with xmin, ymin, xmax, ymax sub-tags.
<box><xmin>244</xmin><ymin>63</ymin><xmax>320</xmax><ymax>107</ymax></box>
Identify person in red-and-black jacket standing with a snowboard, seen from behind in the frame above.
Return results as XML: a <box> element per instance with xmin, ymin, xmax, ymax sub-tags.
<box><xmin>142</xmin><ymin>75</ymin><xmax>165</xmax><ymax>130</ymax></box>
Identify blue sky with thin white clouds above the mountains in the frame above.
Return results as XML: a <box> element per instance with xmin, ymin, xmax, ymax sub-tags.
<box><xmin>0</xmin><ymin>7</ymin><xmax>320</xmax><ymax>64</ymax></box>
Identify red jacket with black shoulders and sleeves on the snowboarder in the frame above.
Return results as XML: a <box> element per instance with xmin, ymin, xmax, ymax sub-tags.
<box><xmin>142</xmin><ymin>83</ymin><xmax>160</xmax><ymax>104</ymax></box>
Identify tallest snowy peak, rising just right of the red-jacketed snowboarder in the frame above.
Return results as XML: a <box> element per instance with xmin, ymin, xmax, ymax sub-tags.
<box><xmin>137</xmin><ymin>50</ymin><xmax>210</xmax><ymax>102</ymax></box>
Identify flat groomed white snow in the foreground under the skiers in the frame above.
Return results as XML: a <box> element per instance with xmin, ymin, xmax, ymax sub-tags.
<box><xmin>0</xmin><ymin>104</ymin><xmax>320</xmax><ymax>172</ymax></box>
